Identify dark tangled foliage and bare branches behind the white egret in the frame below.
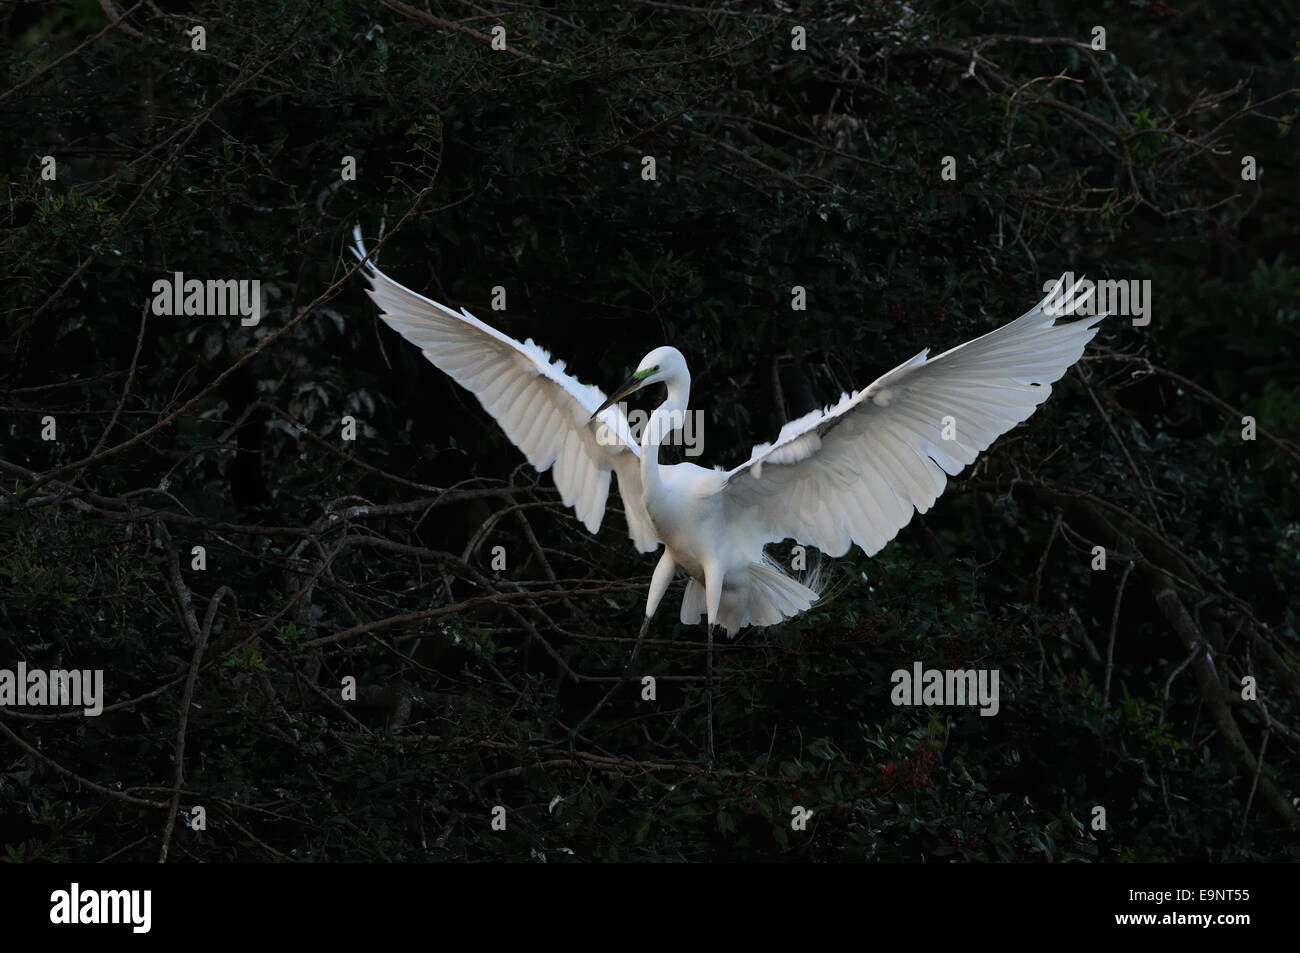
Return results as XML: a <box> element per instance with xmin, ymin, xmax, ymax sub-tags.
<box><xmin>0</xmin><ymin>0</ymin><xmax>1300</xmax><ymax>862</ymax></box>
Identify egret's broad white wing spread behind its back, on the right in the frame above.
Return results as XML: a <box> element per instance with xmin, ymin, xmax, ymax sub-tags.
<box><xmin>722</xmin><ymin>280</ymin><xmax>1105</xmax><ymax>556</ymax></box>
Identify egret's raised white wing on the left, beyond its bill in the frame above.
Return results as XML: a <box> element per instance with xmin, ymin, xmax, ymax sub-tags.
<box><xmin>352</xmin><ymin>226</ymin><xmax>659</xmax><ymax>553</ymax></box>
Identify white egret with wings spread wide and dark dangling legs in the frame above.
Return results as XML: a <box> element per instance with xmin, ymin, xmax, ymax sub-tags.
<box><xmin>354</xmin><ymin>228</ymin><xmax>1106</xmax><ymax>768</ymax></box>
